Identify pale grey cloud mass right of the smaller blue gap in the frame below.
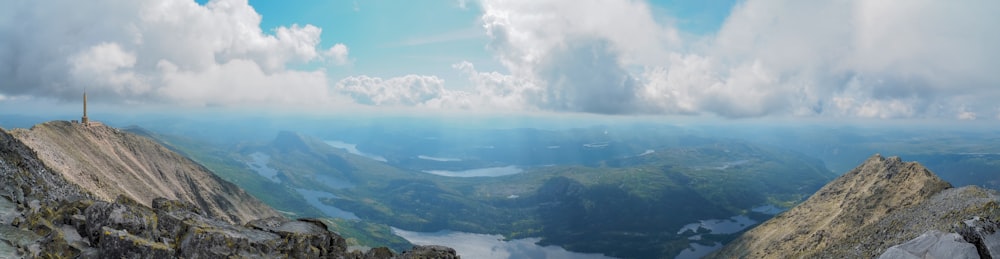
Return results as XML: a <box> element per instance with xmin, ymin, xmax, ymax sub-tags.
<box><xmin>696</xmin><ymin>0</ymin><xmax>1000</xmax><ymax>118</ymax></box>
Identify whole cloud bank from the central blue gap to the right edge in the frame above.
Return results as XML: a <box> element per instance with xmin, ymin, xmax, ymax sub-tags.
<box><xmin>468</xmin><ymin>0</ymin><xmax>1000</xmax><ymax>119</ymax></box>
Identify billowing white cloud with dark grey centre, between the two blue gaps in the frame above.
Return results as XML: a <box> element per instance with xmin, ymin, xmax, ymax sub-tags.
<box><xmin>482</xmin><ymin>0</ymin><xmax>679</xmax><ymax>113</ymax></box>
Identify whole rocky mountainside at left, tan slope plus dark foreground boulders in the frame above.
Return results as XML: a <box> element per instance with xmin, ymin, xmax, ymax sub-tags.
<box><xmin>0</xmin><ymin>122</ymin><xmax>458</xmax><ymax>258</ymax></box>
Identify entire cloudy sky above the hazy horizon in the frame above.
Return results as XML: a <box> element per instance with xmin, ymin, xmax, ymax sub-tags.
<box><xmin>0</xmin><ymin>0</ymin><xmax>1000</xmax><ymax>121</ymax></box>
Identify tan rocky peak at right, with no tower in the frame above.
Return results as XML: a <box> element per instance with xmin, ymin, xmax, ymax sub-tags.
<box><xmin>711</xmin><ymin>155</ymin><xmax>1000</xmax><ymax>258</ymax></box>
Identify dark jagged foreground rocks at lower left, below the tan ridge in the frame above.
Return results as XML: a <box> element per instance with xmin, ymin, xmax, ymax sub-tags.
<box><xmin>0</xmin><ymin>125</ymin><xmax>458</xmax><ymax>258</ymax></box>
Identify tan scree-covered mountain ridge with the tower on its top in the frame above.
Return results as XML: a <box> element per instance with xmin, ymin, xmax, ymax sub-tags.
<box><xmin>11</xmin><ymin>121</ymin><xmax>280</xmax><ymax>224</ymax></box>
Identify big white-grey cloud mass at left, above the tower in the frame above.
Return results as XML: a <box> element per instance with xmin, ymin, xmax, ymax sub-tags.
<box><xmin>0</xmin><ymin>0</ymin><xmax>350</xmax><ymax>106</ymax></box>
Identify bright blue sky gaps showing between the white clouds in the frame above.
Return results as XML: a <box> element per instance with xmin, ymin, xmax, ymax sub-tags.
<box><xmin>230</xmin><ymin>0</ymin><xmax>736</xmax><ymax>87</ymax></box>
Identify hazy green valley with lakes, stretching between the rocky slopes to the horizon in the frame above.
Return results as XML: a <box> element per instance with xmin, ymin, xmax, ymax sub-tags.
<box><xmin>3</xmin><ymin>116</ymin><xmax>998</xmax><ymax>258</ymax></box>
